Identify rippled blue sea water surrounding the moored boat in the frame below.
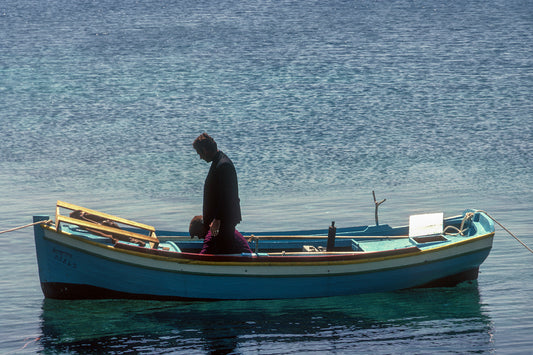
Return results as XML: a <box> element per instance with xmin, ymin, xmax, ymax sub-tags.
<box><xmin>0</xmin><ymin>0</ymin><xmax>533</xmax><ymax>354</ymax></box>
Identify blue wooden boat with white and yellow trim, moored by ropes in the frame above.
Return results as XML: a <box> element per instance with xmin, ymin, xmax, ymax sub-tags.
<box><xmin>34</xmin><ymin>201</ymin><xmax>494</xmax><ymax>300</ymax></box>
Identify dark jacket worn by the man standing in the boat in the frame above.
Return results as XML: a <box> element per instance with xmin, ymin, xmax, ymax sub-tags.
<box><xmin>203</xmin><ymin>151</ymin><xmax>242</xmax><ymax>226</ymax></box>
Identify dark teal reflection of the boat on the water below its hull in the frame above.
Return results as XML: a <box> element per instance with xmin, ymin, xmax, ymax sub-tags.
<box><xmin>40</xmin><ymin>283</ymin><xmax>494</xmax><ymax>354</ymax></box>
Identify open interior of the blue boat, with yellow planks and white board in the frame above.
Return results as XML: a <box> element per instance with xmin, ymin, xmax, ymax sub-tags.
<box><xmin>50</xmin><ymin>201</ymin><xmax>475</xmax><ymax>256</ymax></box>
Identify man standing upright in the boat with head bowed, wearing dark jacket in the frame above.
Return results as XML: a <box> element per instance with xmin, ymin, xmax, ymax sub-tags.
<box><xmin>193</xmin><ymin>133</ymin><xmax>242</xmax><ymax>254</ymax></box>
